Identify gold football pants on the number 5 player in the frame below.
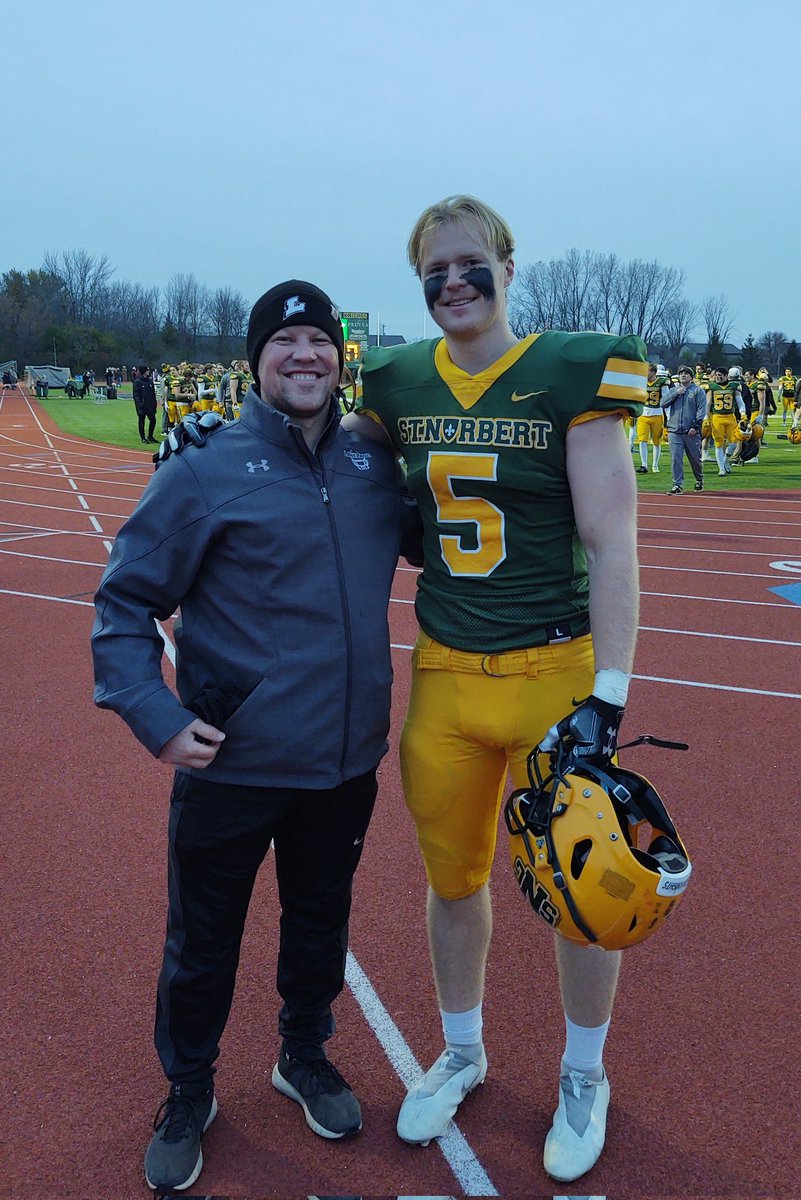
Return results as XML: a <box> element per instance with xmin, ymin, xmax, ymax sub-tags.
<box><xmin>401</xmin><ymin>632</ymin><xmax>595</xmax><ymax>900</ymax></box>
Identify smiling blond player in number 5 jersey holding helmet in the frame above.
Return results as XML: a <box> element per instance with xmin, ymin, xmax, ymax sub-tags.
<box><xmin>345</xmin><ymin>197</ymin><xmax>648</xmax><ymax>1180</ymax></box>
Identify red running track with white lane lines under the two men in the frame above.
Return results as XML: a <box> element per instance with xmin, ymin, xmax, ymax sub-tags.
<box><xmin>0</xmin><ymin>391</ymin><xmax>801</xmax><ymax>1200</ymax></box>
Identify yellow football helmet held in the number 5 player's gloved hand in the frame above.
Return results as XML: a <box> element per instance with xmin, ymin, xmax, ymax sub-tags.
<box><xmin>504</xmin><ymin>738</ymin><xmax>692</xmax><ymax>950</ymax></box>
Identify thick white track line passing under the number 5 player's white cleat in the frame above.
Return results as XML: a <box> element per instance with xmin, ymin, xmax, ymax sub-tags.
<box><xmin>345</xmin><ymin>950</ymin><xmax>498</xmax><ymax>1196</ymax></box>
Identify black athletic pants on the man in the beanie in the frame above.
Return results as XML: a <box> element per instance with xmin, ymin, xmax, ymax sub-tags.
<box><xmin>155</xmin><ymin>770</ymin><xmax>377</xmax><ymax>1090</ymax></box>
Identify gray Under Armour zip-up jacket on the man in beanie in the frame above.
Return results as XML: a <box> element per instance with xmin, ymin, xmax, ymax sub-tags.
<box><xmin>92</xmin><ymin>389</ymin><xmax>417</xmax><ymax>788</ymax></box>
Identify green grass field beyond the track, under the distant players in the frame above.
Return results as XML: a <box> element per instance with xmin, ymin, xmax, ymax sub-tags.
<box><xmin>37</xmin><ymin>384</ymin><xmax>801</xmax><ymax>492</ymax></box>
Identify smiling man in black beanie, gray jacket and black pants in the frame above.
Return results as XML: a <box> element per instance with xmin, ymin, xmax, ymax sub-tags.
<box><xmin>92</xmin><ymin>280</ymin><xmax>416</xmax><ymax>1190</ymax></box>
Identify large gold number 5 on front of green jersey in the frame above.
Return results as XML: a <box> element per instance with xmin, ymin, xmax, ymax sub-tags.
<box><xmin>426</xmin><ymin>450</ymin><xmax>506</xmax><ymax>577</ymax></box>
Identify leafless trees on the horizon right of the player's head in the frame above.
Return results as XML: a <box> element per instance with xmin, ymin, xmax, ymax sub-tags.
<box><xmin>510</xmin><ymin>250</ymin><xmax>801</xmax><ymax>374</ymax></box>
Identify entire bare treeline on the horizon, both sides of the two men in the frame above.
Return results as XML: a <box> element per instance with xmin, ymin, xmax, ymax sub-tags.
<box><xmin>0</xmin><ymin>243</ymin><xmax>801</xmax><ymax>376</ymax></box>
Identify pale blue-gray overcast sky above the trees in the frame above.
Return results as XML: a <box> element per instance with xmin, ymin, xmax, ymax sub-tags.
<box><xmin>0</xmin><ymin>0</ymin><xmax>801</xmax><ymax>340</ymax></box>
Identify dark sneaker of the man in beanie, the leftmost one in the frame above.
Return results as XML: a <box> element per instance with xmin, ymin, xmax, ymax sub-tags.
<box><xmin>145</xmin><ymin>1084</ymin><xmax>217</xmax><ymax>1192</ymax></box>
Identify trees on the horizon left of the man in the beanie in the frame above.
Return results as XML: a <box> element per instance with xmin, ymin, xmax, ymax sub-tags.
<box><xmin>0</xmin><ymin>250</ymin><xmax>251</xmax><ymax>371</ymax></box>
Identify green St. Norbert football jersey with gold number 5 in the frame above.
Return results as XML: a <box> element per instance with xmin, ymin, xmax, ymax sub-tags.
<box><xmin>362</xmin><ymin>331</ymin><xmax>648</xmax><ymax>654</ymax></box>
